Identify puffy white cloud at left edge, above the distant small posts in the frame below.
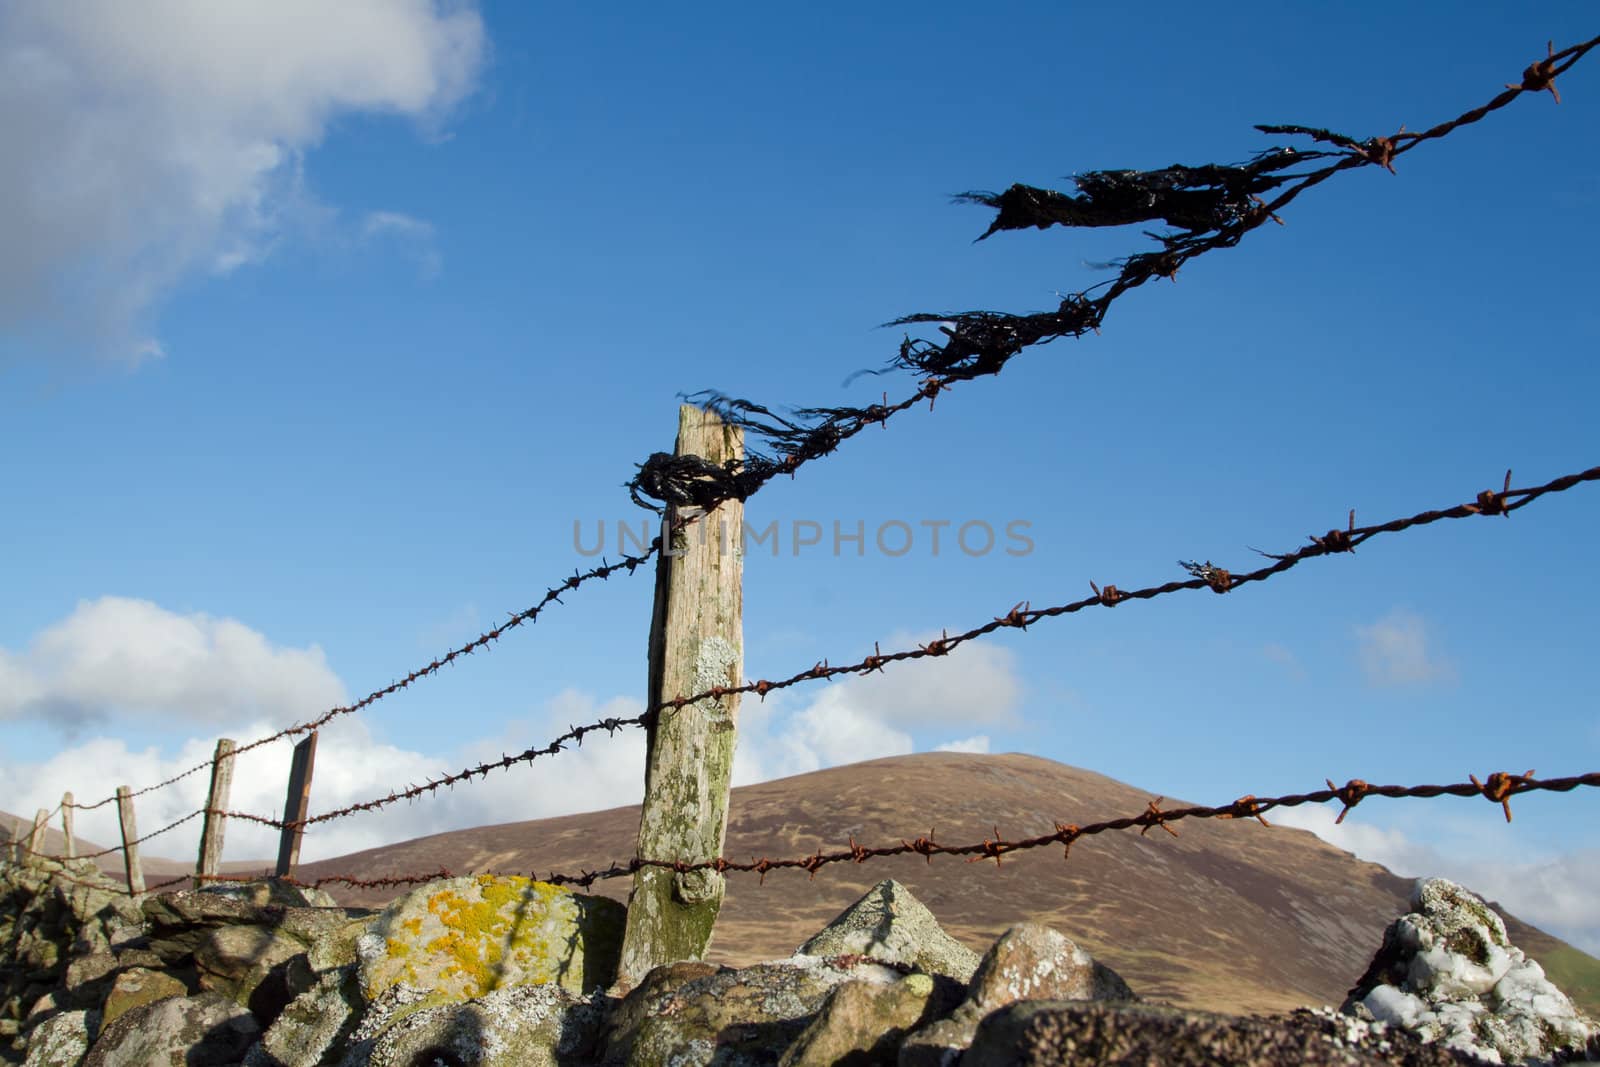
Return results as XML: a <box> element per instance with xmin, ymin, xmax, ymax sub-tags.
<box><xmin>0</xmin><ymin>597</ymin><xmax>344</xmax><ymax>733</ymax></box>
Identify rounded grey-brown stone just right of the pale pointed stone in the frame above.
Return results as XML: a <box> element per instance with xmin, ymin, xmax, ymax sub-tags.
<box><xmin>899</xmin><ymin>923</ymin><xmax>1138</xmax><ymax>1065</ymax></box>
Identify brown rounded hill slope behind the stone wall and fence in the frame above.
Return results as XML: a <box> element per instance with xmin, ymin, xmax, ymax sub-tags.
<box><xmin>278</xmin><ymin>752</ymin><xmax>1600</xmax><ymax>1013</ymax></box>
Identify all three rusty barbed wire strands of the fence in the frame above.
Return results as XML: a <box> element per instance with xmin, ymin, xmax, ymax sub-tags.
<box><xmin>11</xmin><ymin>37</ymin><xmax>1600</xmax><ymax>940</ymax></box>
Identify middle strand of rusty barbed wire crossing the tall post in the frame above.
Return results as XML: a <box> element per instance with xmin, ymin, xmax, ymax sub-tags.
<box><xmin>212</xmin><ymin>467</ymin><xmax>1600</xmax><ymax>829</ymax></box>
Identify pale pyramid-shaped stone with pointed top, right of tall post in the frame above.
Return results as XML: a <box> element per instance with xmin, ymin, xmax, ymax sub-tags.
<box><xmin>797</xmin><ymin>878</ymin><xmax>978</xmax><ymax>982</ymax></box>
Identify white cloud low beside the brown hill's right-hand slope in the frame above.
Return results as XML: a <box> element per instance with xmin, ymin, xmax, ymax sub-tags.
<box><xmin>1269</xmin><ymin>805</ymin><xmax>1600</xmax><ymax>955</ymax></box>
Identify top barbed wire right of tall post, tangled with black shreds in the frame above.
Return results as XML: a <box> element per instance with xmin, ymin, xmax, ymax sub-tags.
<box><xmin>627</xmin><ymin>37</ymin><xmax>1600</xmax><ymax>512</ymax></box>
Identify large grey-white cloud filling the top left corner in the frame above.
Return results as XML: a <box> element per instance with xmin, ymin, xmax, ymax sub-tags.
<box><xmin>0</xmin><ymin>0</ymin><xmax>486</xmax><ymax>365</ymax></box>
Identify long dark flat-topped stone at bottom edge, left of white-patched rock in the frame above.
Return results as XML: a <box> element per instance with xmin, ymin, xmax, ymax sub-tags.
<box><xmin>953</xmin><ymin>1000</ymin><xmax>1477</xmax><ymax>1067</ymax></box>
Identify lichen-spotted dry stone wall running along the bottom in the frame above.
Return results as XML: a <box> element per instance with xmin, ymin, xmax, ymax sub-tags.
<box><xmin>0</xmin><ymin>861</ymin><xmax>1600</xmax><ymax>1067</ymax></box>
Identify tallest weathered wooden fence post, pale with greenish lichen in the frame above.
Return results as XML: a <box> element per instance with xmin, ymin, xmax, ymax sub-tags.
<box><xmin>619</xmin><ymin>405</ymin><xmax>744</xmax><ymax>984</ymax></box>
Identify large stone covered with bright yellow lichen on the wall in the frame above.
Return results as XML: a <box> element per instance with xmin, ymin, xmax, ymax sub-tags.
<box><xmin>357</xmin><ymin>875</ymin><xmax>627</xmax><ymax>1000</ymax></box>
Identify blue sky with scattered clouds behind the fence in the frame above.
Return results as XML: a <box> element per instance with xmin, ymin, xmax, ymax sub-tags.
<box><xmin>0</xmin><ymin>2</ymin><xmax>1600</xmax><ymax>950</ymax></box>
